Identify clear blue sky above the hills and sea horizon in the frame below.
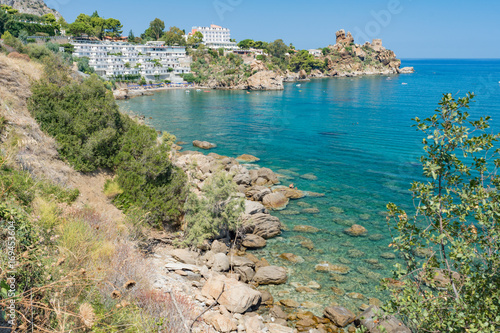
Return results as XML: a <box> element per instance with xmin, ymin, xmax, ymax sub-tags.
<box><xmin>51</xmin><ymin>0</ymin><xmax>500</xmax><ymax>58</ymax></box>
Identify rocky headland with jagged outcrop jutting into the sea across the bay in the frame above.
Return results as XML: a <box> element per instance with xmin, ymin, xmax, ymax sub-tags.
<box><xmin>188</xmin><ymin>30</ymin><xmax>414</xmax><ymax>90</ymax></box>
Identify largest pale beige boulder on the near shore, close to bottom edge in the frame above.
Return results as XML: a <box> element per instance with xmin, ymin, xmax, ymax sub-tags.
<box><xmin>201</xmin><ymin>275</ymin><xmax>261</xmax><ymax>313</ymax></box>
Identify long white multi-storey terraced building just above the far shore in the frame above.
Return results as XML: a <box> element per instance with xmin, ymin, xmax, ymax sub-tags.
<box><xmin>71</xmin><ymin>40</ymin><xmax>191</xmax><ymax>83</ymax></box>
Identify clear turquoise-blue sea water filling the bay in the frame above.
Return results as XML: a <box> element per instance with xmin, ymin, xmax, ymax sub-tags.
<box><xmin>119</xmin><ymin>60</ymin><xmax>500</xmax><ymax>311</ymax></box>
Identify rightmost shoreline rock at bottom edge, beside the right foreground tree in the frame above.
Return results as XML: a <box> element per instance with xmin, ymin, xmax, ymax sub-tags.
<box><xmin>356</xmin><ymin>305</ymin><xmax>411</xmax><ymax>333</ymax></box>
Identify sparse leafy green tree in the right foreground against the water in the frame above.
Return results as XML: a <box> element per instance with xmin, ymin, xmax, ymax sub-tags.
<box><xmin>386</xmin><ymin>94</ymin><xmax>500</xmax><ymax>332</ymax></box>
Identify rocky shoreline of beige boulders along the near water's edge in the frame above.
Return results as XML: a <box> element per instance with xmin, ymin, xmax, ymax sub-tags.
<box><xmin>142</xmin><ymin>141</ymin><xmax>410</xmax><ymax>333</ymax></box>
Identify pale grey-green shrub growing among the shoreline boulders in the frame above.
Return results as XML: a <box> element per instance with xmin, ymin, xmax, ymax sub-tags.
<box><xmin>185</xmin><ymin>171</ymin><xmax>244</xmax><ymax>245</ymax></box>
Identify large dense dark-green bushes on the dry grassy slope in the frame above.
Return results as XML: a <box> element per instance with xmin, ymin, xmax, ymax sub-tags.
<box><xmin>29</xmin><ymin>48</ymin><xmax>186</xmax><ymax>227</ymax></box>
